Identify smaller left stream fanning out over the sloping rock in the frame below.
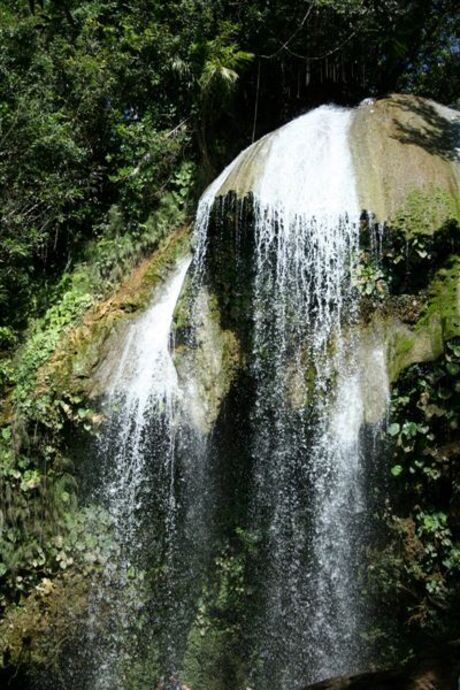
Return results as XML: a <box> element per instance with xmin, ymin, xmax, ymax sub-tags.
<box><xmin>87</xmin><ymin>257</ymin><xmax>190</xmax><ymax>690</ymax></box>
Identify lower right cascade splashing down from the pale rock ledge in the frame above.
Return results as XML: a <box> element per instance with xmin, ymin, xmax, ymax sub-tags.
<box><xmin>310</xmin><ymin>334</ymin><xmax>389</xmax><ymax>677</ymax></box>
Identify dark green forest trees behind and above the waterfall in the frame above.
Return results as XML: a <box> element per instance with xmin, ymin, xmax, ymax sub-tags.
<box><xmin>0</xmin><ymin>0</ymin><xmax>458</xmax><ymax>338</ymax></box>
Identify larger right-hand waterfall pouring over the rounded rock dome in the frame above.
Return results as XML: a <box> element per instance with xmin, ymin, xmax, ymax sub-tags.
<box><xmin>195</xmin><ymin>106</ymin><xmax>388</xmax><ymax>690</ymax></box>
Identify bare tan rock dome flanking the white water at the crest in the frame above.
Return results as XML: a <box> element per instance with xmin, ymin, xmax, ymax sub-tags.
<box><xmin>210</xmin><ymin>95</ymin><xmax>460</xmax><ymax>232</ymax></box>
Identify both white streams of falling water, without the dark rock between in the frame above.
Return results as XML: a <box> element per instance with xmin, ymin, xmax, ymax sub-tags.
<box><xmin>81</xmin><ymin>106</ymin><xmax>388</xmax><ymax>690</ymax></box>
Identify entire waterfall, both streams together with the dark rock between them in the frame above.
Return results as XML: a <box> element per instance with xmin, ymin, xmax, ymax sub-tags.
<box><xmin>71</xmin><ymin>106</ymin><xmax>388</xmax><ymax>690</ymax></box>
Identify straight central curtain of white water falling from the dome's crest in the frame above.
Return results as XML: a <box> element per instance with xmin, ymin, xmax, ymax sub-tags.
<box><xmin>244</xmin><ymin>108</ymin><xmax>359</xmax><ymax>687</ymax></box>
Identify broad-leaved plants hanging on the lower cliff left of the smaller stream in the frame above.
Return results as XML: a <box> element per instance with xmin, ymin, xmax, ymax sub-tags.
<box><xmin>0</xmin><ymin>408</ymin><xmax>117</xmax><ymax>608</ymax></box>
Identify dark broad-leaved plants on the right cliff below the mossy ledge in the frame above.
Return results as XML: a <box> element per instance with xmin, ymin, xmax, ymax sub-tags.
<box><xmin>380</xmin><ymin>338</ymin><xmax>460</xmax><ymax>636</ymax></box>
